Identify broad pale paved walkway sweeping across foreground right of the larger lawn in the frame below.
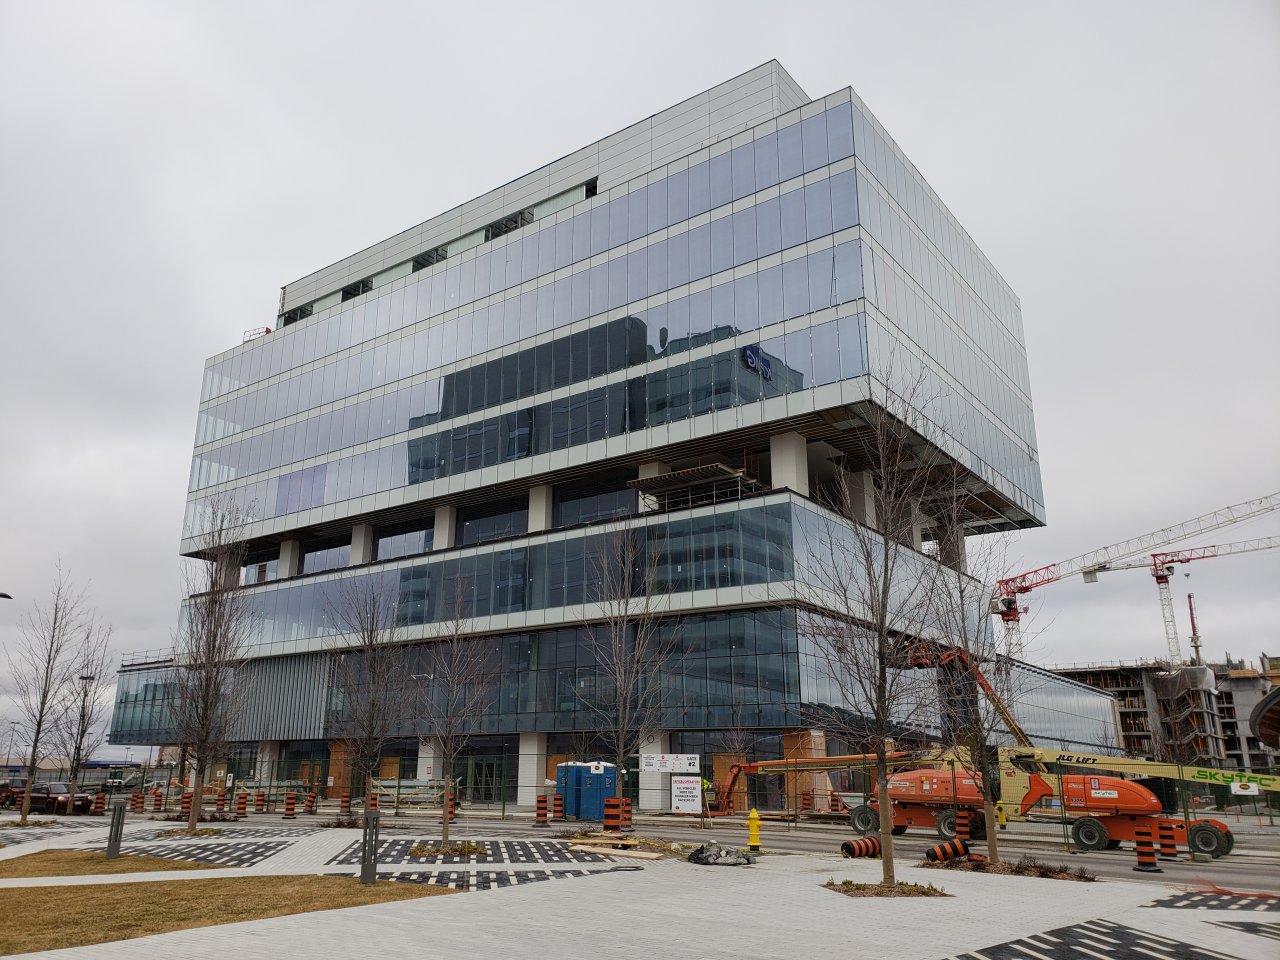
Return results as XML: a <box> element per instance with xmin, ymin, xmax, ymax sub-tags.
<box><xmin>12</xmin><ymin>856</ymin><xmax>1276</xmax><ymax>960</ymax></box>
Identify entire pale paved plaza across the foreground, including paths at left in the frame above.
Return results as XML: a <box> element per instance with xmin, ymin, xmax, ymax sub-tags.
<box><xmin>0</xmin><ymin>820</ymin><xmax>1280</xmax><ymax>960</ymax></box>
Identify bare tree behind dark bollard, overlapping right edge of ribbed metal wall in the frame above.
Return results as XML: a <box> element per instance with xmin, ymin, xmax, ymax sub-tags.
<box><xmin>328</xmin><ymin>573</ymin><xmax>411</xmax><ymax>796</ymax></box>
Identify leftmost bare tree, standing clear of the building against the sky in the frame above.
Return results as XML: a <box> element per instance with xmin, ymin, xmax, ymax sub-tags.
<box><xmin>5</xmin><ymin>563</ymin><xmax>97</xmax><ymax>824</ymax></box>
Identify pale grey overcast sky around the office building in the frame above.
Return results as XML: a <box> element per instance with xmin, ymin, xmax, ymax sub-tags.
<box><xmin>0</xmin><ymin>0</ymin><xmax>1280</xmax><ymax>742</ymax></box>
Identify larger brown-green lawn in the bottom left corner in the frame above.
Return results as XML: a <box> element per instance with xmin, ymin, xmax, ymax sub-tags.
<box><xmin>0</xmin><ymin>877</ymin><xmax>456</xmax><ymax>955</ymax></box>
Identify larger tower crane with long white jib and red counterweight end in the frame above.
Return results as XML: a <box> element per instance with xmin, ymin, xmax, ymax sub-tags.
<box><xmin>991</xmin><ymin>492</ymin><xmax>1280</xmax><ymax>657</ymax></box>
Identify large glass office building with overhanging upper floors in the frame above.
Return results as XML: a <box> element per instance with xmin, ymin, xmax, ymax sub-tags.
<box><xmin>111</xmin><ymin>61</ymin><xmax>1114</xmax><ymax>805</ymax></box>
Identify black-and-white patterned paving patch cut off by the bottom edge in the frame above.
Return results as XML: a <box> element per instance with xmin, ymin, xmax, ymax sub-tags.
<box><xmin>951</xmin><ymin>920</ymin><xmax>1235</xmax><ymax>960</ymax></box>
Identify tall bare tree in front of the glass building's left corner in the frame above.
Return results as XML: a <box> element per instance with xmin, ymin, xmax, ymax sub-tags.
<box><xmin>173</xmin><ymin>498</ymin><xmax>253</xmax><ymax>831</ymax></box>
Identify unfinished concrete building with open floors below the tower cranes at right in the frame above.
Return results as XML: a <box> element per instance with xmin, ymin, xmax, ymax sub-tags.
<box><xmin>1052</xmin><ymin>660</ymin><xmax>1231</xmax><ymax>767</ymax></box>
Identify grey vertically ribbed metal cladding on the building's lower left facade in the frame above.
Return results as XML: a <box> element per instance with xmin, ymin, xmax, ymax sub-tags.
<box><xmin>236</xmin><ymin>653</ymin><xmax>329</xmax><ymax>740</ymax></box>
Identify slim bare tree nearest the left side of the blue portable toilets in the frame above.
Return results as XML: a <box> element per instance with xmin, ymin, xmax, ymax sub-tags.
<box><xmin>415</xmin><ymin>576</ymin><xmax>498</xmax><ymax>844</ymax></box>
